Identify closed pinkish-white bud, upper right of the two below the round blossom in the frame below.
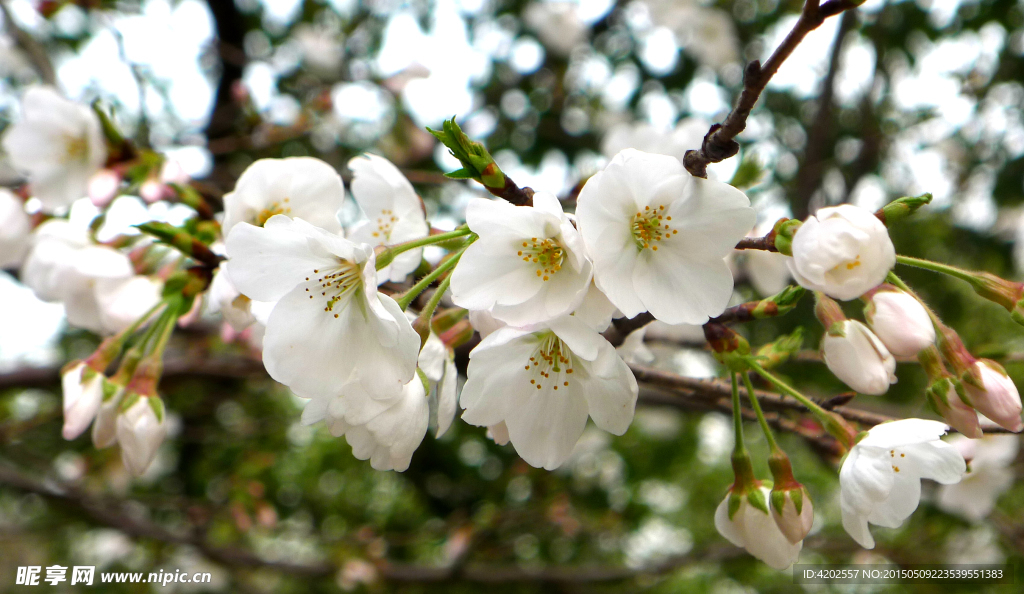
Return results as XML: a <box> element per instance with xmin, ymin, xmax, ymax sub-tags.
<box><xmin>864</xmin><ymin>291</ymin><xmax>935</xmax><ymax>356</ymax></box>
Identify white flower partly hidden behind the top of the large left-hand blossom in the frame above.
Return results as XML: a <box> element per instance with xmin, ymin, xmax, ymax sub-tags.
<box><xmin>223</xmin><ymin>157</ymin><xmax>345</xmax><ymax>237</ymax></box>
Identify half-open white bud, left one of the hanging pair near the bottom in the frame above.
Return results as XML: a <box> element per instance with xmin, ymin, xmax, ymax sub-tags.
<box><xmin>715</xmin><ymin>486</ymin><xmax>804</xmax><ymax>570</ymax></box>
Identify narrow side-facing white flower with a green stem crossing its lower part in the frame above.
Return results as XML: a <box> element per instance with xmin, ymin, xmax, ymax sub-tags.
<box><xmin>348</xmin><ymin>154</ymin><xmax>430</xmax><ymax>283</ymax></box>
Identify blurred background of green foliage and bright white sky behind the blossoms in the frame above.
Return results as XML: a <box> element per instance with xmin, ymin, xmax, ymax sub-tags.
<box><xmin>0</xmin><ymin>0</ymin><xmax>1024</xmax><ymax>592</ymax></box>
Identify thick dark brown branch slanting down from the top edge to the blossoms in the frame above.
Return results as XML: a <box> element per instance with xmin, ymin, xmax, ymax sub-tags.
<box><xmin>683</xmin><ymin>0</ymin><xmax>858</xmax><ymax>177</ymax></box>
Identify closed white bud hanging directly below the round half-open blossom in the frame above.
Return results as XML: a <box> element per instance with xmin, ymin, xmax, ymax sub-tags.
<box><xmin>821</xmin><ymin>320</ymin><xmax>896</xmax><ymax>395</ymax></box>
